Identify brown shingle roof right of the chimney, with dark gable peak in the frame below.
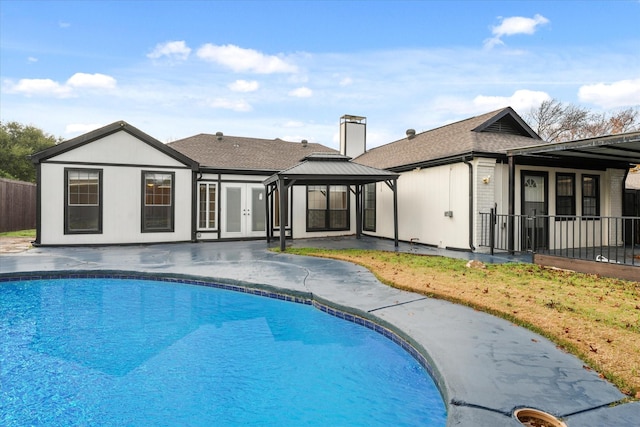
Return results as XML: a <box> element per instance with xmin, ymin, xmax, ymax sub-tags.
<box><xmin>354</xmin><ymin>108</ymin><xmax>542</xmax><ymax>169</ymax></box>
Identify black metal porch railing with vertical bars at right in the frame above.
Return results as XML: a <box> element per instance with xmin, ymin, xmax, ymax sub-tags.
<box><xmin>480</xmin><ymin>209</ymin><xmax>640</xmax><ymax>266</ymax></box>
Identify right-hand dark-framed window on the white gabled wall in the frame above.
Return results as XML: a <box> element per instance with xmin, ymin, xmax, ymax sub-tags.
<box><xmin>142</xmin><ymin>172</ymin><xmax>175</xmax><ymax>232</ymax></box>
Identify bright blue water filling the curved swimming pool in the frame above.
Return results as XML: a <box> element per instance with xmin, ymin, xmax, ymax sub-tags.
<box><xmin>0</xmin><ymin>279</ymin><xmax>446</xmax><ymax>426</ymax></box>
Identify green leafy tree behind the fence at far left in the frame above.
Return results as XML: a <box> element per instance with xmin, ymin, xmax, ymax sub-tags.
<box><xmin>0</xmin><ymin>122</ymin><xmax>62</xmax><ymax>182</ymax></box>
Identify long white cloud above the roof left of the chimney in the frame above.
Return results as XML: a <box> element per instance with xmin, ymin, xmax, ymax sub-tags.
<box><xmin>197</xmin><ymin>43</ymin><xmax>298</xmax><ymax>74</ymax></box>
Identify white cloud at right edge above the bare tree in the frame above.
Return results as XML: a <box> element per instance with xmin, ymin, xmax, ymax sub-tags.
<box><xmin>578</xmin><ymin>78</ymin><xmax>640</xmax><ymax>108</ymax></box>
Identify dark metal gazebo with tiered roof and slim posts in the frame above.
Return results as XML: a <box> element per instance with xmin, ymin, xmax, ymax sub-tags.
<box><xmin>263</xmin><ymin>153</ymin><xmax>399</xmax><ymax>251</ymax></box>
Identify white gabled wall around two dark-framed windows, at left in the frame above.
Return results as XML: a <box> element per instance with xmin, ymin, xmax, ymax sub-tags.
<box><xmin>40</xmin><ymin>132</ymin><xmax>192</xmax><ymax>245</ymax></box>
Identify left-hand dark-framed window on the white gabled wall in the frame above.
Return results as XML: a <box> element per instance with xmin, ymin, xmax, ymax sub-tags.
<box><xmin>64</xmin><ymin>169</ymin><xmax>102</xmax><ymax>234</ymax></box>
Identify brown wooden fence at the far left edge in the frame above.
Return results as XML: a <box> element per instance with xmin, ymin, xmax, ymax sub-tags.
<box><xmin>0</xmin><ymin>178</ymin><xmax>36</xmax><ymax>233</ymax></box>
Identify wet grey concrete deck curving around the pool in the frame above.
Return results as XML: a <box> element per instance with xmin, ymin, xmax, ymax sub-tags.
<box><xmin>0</xmin><ymin>238</ymin><xmax>640</xmax><ymax>427</ymax></box>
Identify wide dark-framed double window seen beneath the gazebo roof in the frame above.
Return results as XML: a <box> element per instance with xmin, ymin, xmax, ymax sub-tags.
<box><xmin>307</xmin><ymin>185</ymin><xmax>349</xmax><ymax>231</ymax></box>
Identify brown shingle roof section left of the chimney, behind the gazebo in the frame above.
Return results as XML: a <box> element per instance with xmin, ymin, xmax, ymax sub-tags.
<box><xmin>168</xmin><ymin>133</ymin><xmax>336</xmax><ymax>171</ymax></box>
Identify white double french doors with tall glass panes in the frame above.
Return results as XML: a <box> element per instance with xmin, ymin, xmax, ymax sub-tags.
<box><xmin>221</xmin><ymin>183</ymin><xmax>266</xmax><ymax>238</ymax></box>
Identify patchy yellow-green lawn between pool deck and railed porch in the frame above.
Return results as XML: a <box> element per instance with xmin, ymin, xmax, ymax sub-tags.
<box><xmin>287</xmin><ymin>248</ymin><xmax>640</xmax><ymax>398</ymax></box>
